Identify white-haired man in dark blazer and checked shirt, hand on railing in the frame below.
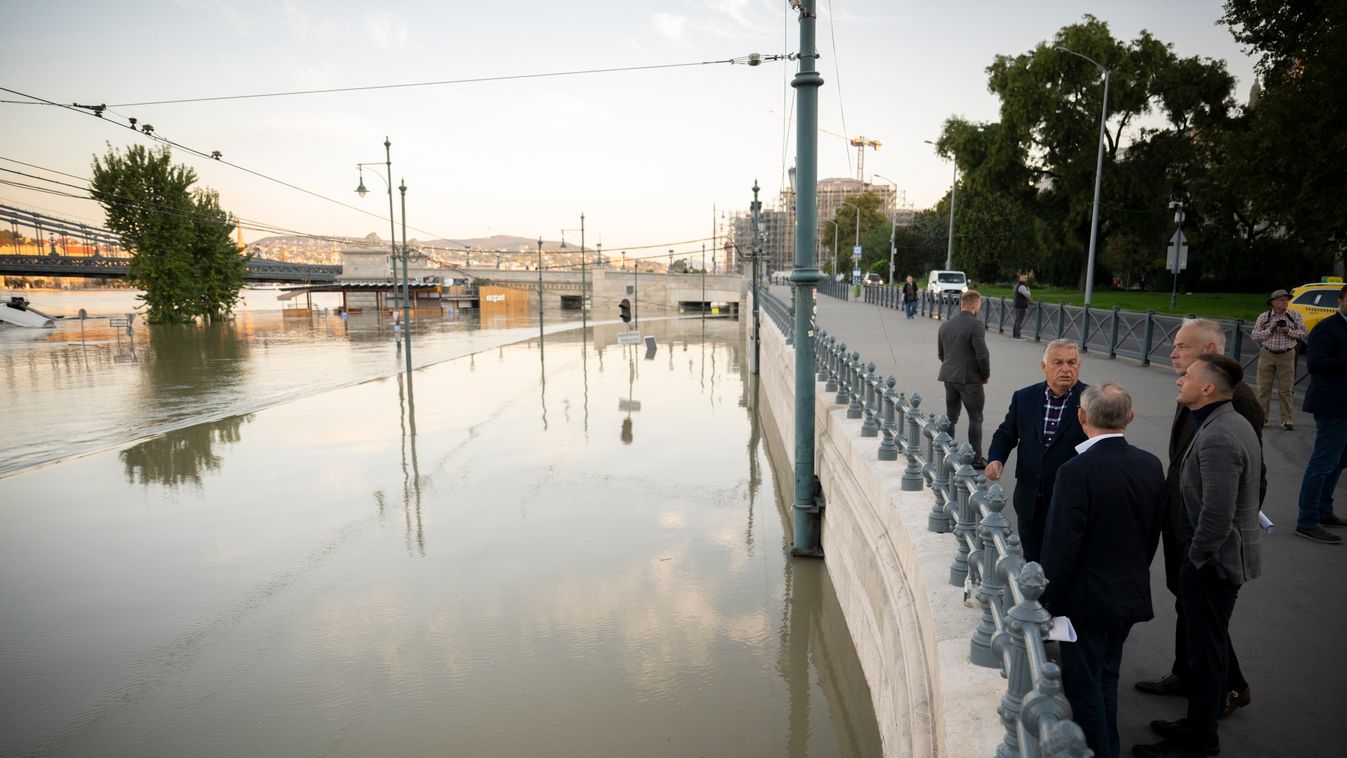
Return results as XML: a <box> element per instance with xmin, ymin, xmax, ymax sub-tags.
<box><xmin>986</xmin><ymin>339</ymin><xmax>1087</xmax><ymax>560</ymax></box>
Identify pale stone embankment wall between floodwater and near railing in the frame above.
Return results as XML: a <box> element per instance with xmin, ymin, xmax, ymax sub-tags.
<box><xmin>759</xmin><ymin>304</ymin><xmax>1005</xmax><ymax>758</ymax></box>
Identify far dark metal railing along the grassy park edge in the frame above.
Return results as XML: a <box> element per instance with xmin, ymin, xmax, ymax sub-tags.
<box><xmin>863</xmin><ymin>287</ymin><xmax>1309</xmax><ymax>385</ymax></box>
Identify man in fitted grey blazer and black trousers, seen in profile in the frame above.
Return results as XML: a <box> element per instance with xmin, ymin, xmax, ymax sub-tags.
<box><xmin>1131</xmin><ymin>353</ymin><xmax>1262</xmax><ymax>758</ymax></box>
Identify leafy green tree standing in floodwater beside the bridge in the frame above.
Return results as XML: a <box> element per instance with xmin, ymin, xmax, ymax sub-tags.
<box><xmin>92</xmin><ymin>145</ymin><xmax>248</xmax><ymax>323</ymax></box>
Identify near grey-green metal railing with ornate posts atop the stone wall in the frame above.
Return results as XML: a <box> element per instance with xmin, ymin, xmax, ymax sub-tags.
<box><xmin>762</xmin><ymin>288</ymin><xmax>1088</xmax><ymax>758</ymax></box>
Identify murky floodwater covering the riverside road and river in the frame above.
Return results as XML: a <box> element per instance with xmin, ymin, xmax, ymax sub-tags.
<box><xmin>0</xmin><ymin>292</ymin><xmax>880</xmax><ymax>757</ymax></box>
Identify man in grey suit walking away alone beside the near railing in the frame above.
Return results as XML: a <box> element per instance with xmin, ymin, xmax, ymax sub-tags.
<box><xmin>936</xmin><ymin>289</ymin><xmax>991</xmax><ymax>469</ymax></box>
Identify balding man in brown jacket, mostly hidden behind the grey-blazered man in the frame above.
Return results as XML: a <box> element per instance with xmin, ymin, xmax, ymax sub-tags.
<box><xmin>1133</xmin><ymin>319</ymin><xmax>1268</xmax><ymax>718</ymax></box>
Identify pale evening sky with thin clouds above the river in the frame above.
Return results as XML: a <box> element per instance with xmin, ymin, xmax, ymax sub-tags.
<box><xmin>0</xmin><ymin>0</ymin><xmax>1254</xmax><ymax>261</ymax></box>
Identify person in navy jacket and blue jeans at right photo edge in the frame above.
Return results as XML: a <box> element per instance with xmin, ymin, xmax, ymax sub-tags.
<box><xmin>1296</xmin><ymin>281</ymin><xmax>1347</xmax><ymax>545</ymax></box>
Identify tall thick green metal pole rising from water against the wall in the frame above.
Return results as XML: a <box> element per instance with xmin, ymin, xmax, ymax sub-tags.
<box><xmin>791</xmin><ymin>0</ymin><xmax>823</xmax><ymax>556</ymax></box>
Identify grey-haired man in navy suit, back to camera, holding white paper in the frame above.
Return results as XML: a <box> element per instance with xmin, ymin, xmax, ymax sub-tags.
<box><xmin>1040</xmin><ymin>382</ymin><xmax>1165</xmax><ymax>758</ymax></box>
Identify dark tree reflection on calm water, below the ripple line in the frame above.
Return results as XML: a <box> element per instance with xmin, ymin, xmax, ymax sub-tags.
<box><xmin>121</xmin><ymin>415</ymin><xmax>252</xmax><ymax>487</ymax></box>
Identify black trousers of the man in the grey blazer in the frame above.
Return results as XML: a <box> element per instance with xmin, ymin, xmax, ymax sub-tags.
<box><xmin>1179</xmin><ymin>560</ymin><xmax>1239</xmax><ymax>746</ymax></box>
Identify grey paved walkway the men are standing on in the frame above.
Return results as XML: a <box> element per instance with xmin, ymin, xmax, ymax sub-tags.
<box><xmin>772</xmin><ymin>285</ymin><xmax>1347</xmax><ymax>757</ymax></box>
